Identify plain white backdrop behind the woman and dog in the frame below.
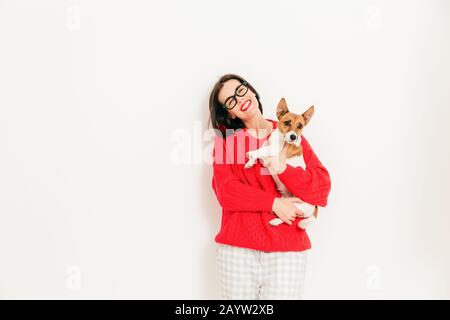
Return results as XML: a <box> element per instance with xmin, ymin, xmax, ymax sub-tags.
<box><xmin>0</xmin><ymin>0</ymin><xmax>450</xmax><ymax>299</ymax></box>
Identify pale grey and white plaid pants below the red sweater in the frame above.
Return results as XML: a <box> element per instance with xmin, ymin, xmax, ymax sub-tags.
<box><xmin>216</xmin><ymin>244</ymin><xmax>307</xmax><ymax>300</ymax></box>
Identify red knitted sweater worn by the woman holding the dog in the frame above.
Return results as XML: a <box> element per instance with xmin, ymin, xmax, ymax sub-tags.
<box><xmin>212</xmin><ymin>119</ymin><xmax>331</xmax><ymax>252</ymax></box>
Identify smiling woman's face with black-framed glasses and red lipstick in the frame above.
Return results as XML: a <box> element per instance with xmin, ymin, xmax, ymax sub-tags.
<box><xmin>218</xmin><ymin>79</ymin><xmax>260</xmax><ymax>121</ymax></box>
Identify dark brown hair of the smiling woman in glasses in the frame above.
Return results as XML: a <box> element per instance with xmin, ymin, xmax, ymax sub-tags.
<box><xmin>209</xmin><ymin>73</ymin><xmax>263</xmax><ymax>137</ymax></box>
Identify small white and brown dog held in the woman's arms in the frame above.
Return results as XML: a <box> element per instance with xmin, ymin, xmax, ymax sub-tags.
<box><xmin>245</xmin><ymin>98</ymin><xmax>318</xmax><ymax>229</ymax></box>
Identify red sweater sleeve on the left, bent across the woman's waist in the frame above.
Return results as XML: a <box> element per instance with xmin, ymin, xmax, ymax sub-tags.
<box><xmin>212</xmin><ymin>135</ymin><xmax>276</xmax><ymax>212</ymax></box>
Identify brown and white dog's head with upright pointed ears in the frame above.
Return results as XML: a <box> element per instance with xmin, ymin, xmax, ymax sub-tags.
<box><xmin>277</xmin><ymin>98</ymin><xmax>314</xmax><ymax>147</ymax></box>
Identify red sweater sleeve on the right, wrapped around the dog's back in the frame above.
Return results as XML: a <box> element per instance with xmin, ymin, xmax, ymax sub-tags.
<box><xmin>278</xmin><ymin>136</ymin><xmax>331</xmax><ymax>207</ymax></box>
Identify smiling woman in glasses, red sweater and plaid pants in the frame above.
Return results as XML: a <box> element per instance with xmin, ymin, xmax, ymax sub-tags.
<box><xmin>209</xmin><ymin>74</ymin><xmax>331</xmax><ymax>299</ymax></box>
